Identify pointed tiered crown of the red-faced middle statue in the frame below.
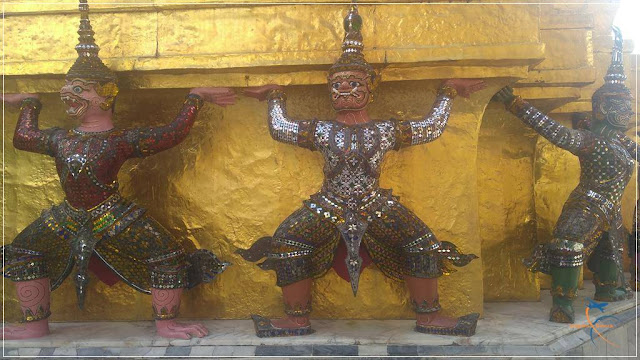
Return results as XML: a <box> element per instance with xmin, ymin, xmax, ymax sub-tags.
<box><xmin>329</xmin><ymin>3</ymin><xmax>375</xmax><ymax>76</ymax></box>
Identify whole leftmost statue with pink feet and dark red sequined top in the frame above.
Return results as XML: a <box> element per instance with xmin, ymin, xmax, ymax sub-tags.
<box><xmin>3</xmin><ymin>0</ymin><xmax>234</xmax><ymax>339</ymax></box>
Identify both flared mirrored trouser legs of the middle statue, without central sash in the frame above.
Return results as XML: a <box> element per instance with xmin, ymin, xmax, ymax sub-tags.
<box><xmin>239</xmin><ymin>194</ymin><xmax>477</xmax><ymax>286</ymax></box>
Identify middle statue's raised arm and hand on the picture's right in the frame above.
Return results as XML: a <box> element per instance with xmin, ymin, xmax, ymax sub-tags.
<box><xmin>396</xmin><ymin>79</ymin><xmax>486</xmax><ymax>148</ymax></box>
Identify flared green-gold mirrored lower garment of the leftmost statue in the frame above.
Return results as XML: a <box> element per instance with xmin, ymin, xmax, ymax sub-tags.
<box><xmin>3</xmin><ymin>194</ymin><xmax>227</xmax><ymax>302</ymax></box>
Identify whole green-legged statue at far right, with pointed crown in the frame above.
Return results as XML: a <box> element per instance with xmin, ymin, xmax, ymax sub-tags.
<box><xmin>495</xmin><ymin>27</ymin><xmax>637</xmax><ymax>323</ymax></box>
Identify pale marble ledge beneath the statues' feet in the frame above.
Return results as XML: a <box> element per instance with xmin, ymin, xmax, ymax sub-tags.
<box><xmin>3</xmin><ymin>282</ymin><xmax>638</xmax><ymax>358</ymax></box>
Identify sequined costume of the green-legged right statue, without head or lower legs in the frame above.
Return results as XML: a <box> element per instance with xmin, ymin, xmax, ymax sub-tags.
<box><xmin>509</xmin><ymin>98</ymin><xmax>636</xmax><ymax>273</ymax></box>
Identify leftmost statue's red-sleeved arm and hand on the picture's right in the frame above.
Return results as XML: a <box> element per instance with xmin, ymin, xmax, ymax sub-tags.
<box><xmin>125</xmin><ymin>88</ymin><xmax>235</xmax><ymax>157</ymax></box>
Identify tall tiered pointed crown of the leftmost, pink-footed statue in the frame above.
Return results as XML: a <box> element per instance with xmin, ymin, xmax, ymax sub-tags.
<box><xmin>66</xmin><ymin>0</ymin><xmax>116</xmax><ymax>83</ymax></box>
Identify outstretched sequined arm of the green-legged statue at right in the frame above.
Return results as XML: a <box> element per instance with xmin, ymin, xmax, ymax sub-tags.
<box><xmin>495</xmin><ymin>86</ymin><xmax>595</xmax><ymax>155</ymax></box>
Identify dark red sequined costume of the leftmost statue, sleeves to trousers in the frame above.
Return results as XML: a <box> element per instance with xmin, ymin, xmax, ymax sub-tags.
<box><xmin>3</xmin><ymin>95</ymin><xmax>224</xmax><ymax>312</ymax></box>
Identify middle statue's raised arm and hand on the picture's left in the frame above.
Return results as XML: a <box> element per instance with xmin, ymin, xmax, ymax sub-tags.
<box><xmin>244</xmin><ymin>85</ymin><xmax>316</xmax><ymax>150</ymax></box>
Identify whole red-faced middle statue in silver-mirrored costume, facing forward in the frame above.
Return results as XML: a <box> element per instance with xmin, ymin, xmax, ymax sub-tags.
<box><xmin>239</xmin><ymin>0</ymin><xmax>484</xmax><ymax>337</ymax></box>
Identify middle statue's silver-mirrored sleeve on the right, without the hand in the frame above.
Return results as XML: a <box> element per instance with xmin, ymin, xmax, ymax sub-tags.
<box><xmin>396</xmin><ymin>86</ymin><xmax>458</xmax><ymax>148</ymax></box>
